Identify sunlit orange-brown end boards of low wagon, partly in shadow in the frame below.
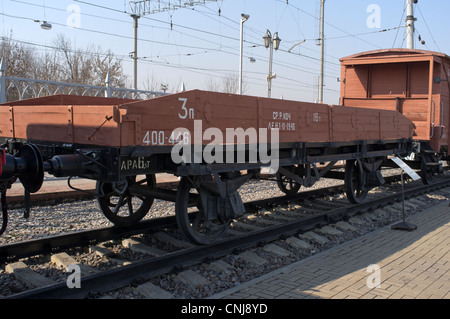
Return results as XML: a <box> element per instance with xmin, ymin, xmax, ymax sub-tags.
<box><xmin>0</xmin><ymin>95</ymin><xmax>131</xmax><ymax>146</ymax></box>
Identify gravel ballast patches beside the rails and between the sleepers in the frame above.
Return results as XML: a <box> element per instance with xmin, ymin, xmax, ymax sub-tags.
<box><xmin>0</xmin><ymin>173</ymin><xmax>450</xmax><ymax>299</ymax></box>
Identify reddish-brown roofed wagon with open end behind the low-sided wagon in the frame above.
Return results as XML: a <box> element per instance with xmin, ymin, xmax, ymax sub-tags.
<box><xmin>340</xmin><ymin>49</ymin><xmax>450</xmax><ymax>184</ymax></box>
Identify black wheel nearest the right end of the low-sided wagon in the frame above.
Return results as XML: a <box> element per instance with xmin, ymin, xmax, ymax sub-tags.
<box><xmin>345</xmin><ymin>160</ymin><xmax>369</xmax><ymax>204</ymax></box>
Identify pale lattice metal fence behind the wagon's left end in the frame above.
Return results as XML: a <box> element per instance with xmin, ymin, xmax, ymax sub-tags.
<box><xmin>0</xmin><ymin>60</ymin><xmax>167</xmax><ymax>103</ymax></box>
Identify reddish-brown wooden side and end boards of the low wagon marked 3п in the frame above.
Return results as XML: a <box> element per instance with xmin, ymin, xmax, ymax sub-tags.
<box><xmin>0</xmin><ymin>90</ymin><xmax>414</xmax><ymax>147</ymax></box>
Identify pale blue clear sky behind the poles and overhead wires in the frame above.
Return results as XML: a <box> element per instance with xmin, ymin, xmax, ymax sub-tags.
<box><xmin>0</xmin><ymin>0</ymin><xmax>450</xmax><ymax>104</ymax></box>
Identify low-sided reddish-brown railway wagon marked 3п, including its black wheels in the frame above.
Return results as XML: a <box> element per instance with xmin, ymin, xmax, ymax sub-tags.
<box><xmin>0</xmin><ymin>90</ymin><xmax>415</xmax><ymax>244</ymax></box>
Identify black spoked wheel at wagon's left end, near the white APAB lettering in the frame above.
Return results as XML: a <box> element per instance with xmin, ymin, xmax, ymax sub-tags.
<box><xmin>96</xmin><ymin>175</ymin><xmax>155</xmax><ymax>226</ymax></box>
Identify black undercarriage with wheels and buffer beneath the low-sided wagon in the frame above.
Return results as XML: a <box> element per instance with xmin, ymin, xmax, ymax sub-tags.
<box><xmin>0</xmin><ymin>139</ymin><xmax>436</xmax><ymax>244</ymax></box>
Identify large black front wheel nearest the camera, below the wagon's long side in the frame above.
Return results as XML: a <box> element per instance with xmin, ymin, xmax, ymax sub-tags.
<box><xmin>175</xmin><ymin>176</ymin><xmax>231</xmax><ymax>245</ymax></box>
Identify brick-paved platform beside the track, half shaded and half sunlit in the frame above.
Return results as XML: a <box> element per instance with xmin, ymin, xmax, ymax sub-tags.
<box><xmin>213</xmin><ymin>200</ymin><xmax>450</xmax><ymax>299</ymax></box>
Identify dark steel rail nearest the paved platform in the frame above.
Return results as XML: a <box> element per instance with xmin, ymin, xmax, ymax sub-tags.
<box><xmin>7</xmin><ymin>178</ymin><xmax>450</xmax><ymax>299</ymax></box>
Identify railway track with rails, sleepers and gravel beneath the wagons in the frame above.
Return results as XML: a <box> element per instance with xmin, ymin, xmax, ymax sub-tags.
<box><xmin>0</xmin><ymin>172</ymin><xmax>450</xmax><ymax>298</ymax></box>
